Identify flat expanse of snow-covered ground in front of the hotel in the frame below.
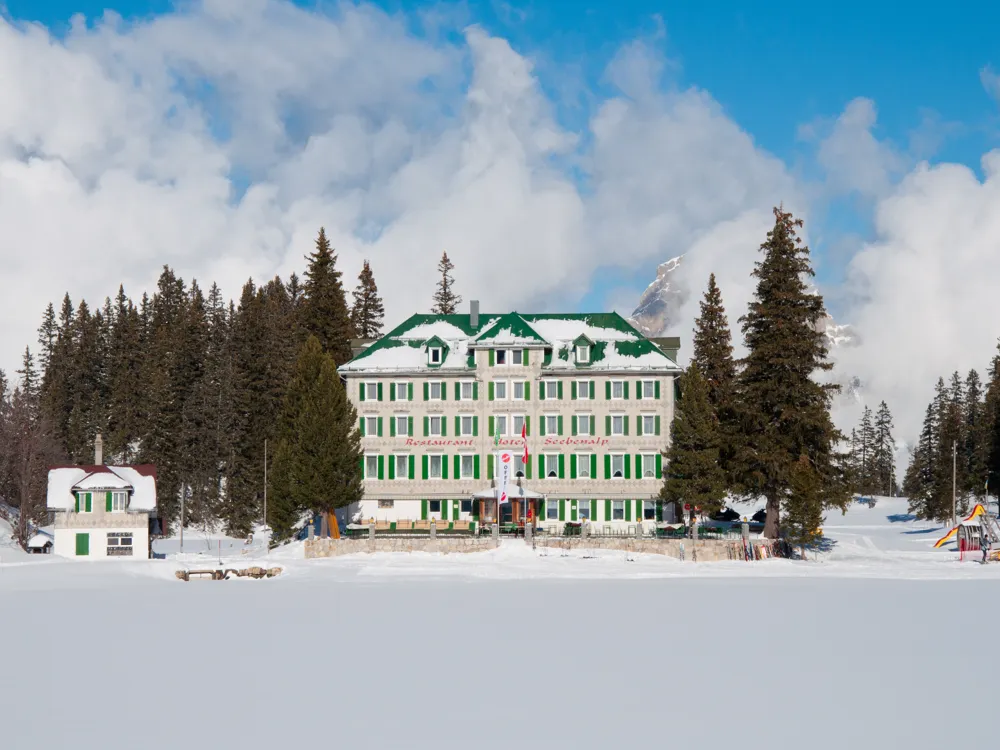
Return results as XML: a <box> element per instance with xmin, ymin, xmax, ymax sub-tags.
<box><xmin>0</xmin><ymin>499</ymin><xmax>1000</xmax><ymax>750</ymax></box>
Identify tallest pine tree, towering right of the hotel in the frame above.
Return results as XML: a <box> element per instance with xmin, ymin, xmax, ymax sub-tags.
<box><xmin>734</xmin><ymin>208</ymin><xmax>850</xmax><ymax>538</ymax></box>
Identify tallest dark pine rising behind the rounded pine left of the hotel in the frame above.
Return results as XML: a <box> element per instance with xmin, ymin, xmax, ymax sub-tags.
<box><xmin>301</xmin><ymin>228</ymin><xmax>354</xmax><ymax>367</ymax></box>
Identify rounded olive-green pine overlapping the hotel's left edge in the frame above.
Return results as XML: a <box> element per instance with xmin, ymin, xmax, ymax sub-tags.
<box><xmin>268</xmin><ymin>336</ymin><xmax>362</xmax><ymax>538</ymax></box>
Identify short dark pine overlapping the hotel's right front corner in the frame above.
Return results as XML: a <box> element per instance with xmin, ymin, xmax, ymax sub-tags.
<box><xmin>660</xmin><ymin>362</ymin><xmax>726</xmax><ymax>516</ymax></box>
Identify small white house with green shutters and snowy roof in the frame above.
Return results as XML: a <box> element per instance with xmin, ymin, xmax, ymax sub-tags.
<box><xmin>47</xmin><ymin>436</ymin><xmax>156</xmax><ymax>559</ymax></box>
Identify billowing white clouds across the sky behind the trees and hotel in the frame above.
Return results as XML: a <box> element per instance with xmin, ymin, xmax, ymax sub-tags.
<box><xmin>0</xmin><ymin>0</ymin><xmax>1000</xmax><ymax>446</ymax></box>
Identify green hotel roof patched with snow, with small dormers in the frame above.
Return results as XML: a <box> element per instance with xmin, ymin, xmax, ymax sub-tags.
<box><xmin>340</xmin><ymin>312</ymin><xmax>680</xmax><ymax>375</ymax></box>
